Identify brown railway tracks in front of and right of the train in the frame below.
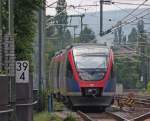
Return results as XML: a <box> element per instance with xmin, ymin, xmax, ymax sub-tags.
<box><xmin>55</xmin><ymin>94</ymin><xmax>150</xmax><ymax>121</ymax></box>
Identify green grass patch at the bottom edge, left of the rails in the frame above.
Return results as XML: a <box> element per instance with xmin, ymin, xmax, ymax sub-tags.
<box><xmin>33</xmin><ymin>112</ymin><xmax>61</xmax><ymax>121</ymax></box>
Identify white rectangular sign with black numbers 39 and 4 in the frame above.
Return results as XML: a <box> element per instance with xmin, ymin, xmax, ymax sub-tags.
<box><xmin>16</xmin><ymin>61</ymin><xmax>29</xmax><ymax>83</ymax></box>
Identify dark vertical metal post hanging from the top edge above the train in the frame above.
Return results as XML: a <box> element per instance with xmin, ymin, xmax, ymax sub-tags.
<box><xmin>100</xmin><ymin>0</ymin><xmax>103</xmax><ymax>36</ymax></box>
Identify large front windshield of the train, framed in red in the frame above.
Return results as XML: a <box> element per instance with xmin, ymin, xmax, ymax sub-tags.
<box><xmin>74</xmin><ymin>48</ymin><xmax>107</xmax><ymax>81</ymax></box>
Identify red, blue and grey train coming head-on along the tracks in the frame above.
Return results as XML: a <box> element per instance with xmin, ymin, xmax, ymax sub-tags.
<box><xmin>49</xmin><ymin>44</ymin><xmax>115</xmax><ymax>106</ymax></box>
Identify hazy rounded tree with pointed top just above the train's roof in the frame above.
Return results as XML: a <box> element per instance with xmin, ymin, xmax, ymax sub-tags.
<box><xmin>80</xmin><ymin>26</ymin><xmax>95</xmax><ymax>43</ymax></box>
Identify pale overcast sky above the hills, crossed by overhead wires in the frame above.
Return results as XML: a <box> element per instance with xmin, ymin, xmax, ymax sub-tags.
<box><xmin>46</xmin><ymin>0</ymin><xmax>150</xmax><ymax>15</ymax></box>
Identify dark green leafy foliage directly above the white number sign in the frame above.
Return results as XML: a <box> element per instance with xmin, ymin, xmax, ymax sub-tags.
<box><xmin>14</xmin><ymin>0</ymin><xmax>42</xmax><ymax>71</ymax></box>
